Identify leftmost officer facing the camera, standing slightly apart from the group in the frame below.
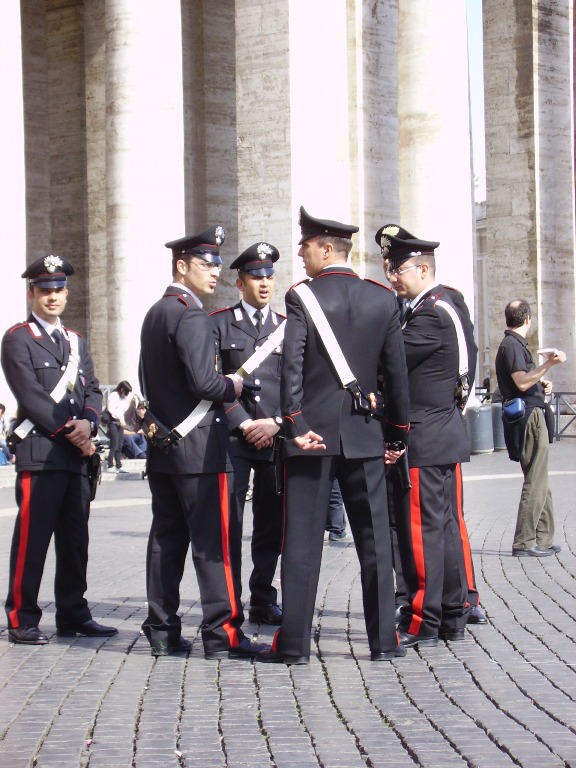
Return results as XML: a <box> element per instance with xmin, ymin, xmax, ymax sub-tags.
<box><xmin>2</xmin><ymin>256</ymin><xmax>117</xmax><ymax>645</ymax></box>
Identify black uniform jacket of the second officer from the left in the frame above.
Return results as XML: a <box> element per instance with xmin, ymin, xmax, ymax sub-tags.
<box><xmin>139</xmin><ymin>285</ymin><xmax>234</xmax><ymax>474</ymax></box>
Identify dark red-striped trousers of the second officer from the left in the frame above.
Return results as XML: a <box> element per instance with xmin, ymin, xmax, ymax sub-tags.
<box><xmin>142</xmin><ymin>472</ymin><xmax>244</xmax><ymax>651</ymax></box>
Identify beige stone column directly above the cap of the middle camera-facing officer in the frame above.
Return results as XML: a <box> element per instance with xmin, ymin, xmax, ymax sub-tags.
<box><xmin>232</xmin><ymin>0</ymin><xmax>294</xmax><ymax>312</ymax></box>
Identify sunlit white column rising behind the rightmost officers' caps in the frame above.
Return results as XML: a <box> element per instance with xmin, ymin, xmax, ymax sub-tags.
<box><xmin>398</xmin><ymin>0</ymin><xmax>474</xmax><ymax>313</ymax></box>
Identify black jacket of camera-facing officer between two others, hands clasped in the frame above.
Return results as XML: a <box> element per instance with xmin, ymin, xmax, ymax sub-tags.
<box><xmin>211</xmin><ymin>302</ymin><xmax>285</xmax><ymax>460</ymax></box>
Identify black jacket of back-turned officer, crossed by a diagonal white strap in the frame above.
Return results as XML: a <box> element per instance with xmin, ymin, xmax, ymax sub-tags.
<box><xmin>280</xmin><ymin>266</ymin><xmax>408</xmax><ymax>458</ymax></box>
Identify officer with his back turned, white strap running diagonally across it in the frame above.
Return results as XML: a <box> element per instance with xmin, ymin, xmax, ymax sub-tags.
<box><xmin>258</xmin><ymin>208</ymin><xmax>408</xmax><ymax>664</ymax></box>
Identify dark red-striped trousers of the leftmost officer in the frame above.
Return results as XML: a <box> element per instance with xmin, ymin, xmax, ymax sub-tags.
<box><xmin>6</xmin><ymin>470</ymin><xmax>91</xmax><ymax>629</ymax></box>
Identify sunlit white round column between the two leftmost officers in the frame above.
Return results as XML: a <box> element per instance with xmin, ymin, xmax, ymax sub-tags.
<box><xmin>102</xmin><ymin>0</ymin><xmax>185</xmax><ymax>386</ymax></box>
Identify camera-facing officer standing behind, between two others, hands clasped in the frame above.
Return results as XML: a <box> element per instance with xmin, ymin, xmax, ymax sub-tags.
<box><xmin>212</xmin><ymin>242</ymin><xmax>284</xmax><ymax>624</ymax></box>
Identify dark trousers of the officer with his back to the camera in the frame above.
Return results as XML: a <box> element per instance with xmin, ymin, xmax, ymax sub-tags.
<box><xmin>275</xmin><ymin>456</ymin><xmax>397</xmax><ymax>656</ymax></box>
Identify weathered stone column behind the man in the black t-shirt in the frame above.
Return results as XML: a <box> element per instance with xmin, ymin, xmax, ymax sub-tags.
<box><xmin>484</xmin><ymin>0</ymin><xmax>576</xmax><ymax>391</ymax></box>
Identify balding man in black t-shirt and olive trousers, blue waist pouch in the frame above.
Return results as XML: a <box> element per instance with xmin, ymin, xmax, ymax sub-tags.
<box><xmin>496</xmin><ymin>299</ymin><xmax>566</xmax><ymax>557</ymax></box>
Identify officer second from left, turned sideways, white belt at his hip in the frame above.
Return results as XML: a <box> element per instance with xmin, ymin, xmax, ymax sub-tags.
<box><xmin>140</xmin><ymin>227</ymin><xmax>268</xmax><ymax>659</ymax></box>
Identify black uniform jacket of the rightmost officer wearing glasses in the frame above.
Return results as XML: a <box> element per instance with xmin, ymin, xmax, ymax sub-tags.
<box><xmin>403</xmin><ymin>285</ymin><xmax>475</xmax><ymax>467</ymax></box>
